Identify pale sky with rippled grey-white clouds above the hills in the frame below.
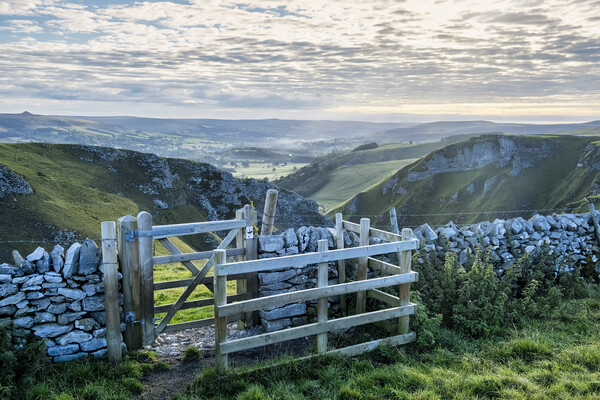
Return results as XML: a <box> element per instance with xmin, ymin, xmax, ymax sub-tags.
<box><xmin>0</xmin><ymin>0</ymin><xmax>600</xmax><ymax>122</ymax></box>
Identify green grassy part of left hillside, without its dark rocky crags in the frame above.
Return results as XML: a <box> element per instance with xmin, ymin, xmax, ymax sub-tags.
<box><xmin>0</xmin><ymin>144</ymin><xmax>213</xmax><ymax>261</ymax></box>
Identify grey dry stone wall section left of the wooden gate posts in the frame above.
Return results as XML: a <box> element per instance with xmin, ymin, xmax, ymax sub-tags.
<box><xmin>0</xmin><ymin>239</ymin><xmax>125</xmax><ymax>362</ymax></box>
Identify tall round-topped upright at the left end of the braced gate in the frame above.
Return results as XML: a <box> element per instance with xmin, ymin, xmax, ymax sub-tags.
<box><xmin>138</xmin><ymin>211</ymin><xmax>156</xmax><ymax>346</ymax></box>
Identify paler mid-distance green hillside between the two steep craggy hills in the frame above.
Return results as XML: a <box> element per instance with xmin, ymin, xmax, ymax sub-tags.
<box><xmin>275</xmin><ymin>135</ymin><xmax>486</xmax><ymax>210</ymax></box>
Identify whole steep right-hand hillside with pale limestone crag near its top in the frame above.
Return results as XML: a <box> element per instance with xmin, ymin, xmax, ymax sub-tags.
<box><xmin>331</xmin><ymin>135</ymin><xmax>600</xmax><ymax>226</ymax></box>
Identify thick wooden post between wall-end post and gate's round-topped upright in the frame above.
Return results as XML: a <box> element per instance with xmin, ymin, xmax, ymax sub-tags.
<box><xmin>117</xmin><ymin>215</ymin><xmax>143</xmax><ymax>350</ymax></box>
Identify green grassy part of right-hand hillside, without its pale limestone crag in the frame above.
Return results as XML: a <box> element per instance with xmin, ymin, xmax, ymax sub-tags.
<box><xmin>334</xmin><ymin>136</ymin><xmax>595</xmax><ymax>225</ymax></box>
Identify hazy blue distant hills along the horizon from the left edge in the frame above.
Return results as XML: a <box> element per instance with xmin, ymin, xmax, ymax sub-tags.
<box><xmin>0</xmin><ymin>112</ymin><xmax>414</xmax><ymax>163</ymax></box>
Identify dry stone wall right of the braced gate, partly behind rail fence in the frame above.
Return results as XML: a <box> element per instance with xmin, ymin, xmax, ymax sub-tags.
<box><xmin>258</xmin><ymin>213</ymin><xmax>600</xmax><ymax>332</ymax></box>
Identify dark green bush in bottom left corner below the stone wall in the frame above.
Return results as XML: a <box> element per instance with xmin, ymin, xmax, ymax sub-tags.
<box><xmin>0</xmin><ymin>325</ymin><xmax>46</xmax><ymax>399</ymax></box>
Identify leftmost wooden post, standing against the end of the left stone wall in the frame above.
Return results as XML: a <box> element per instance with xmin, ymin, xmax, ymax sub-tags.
<box><xmin>101</xmin><ymin>221</ymin><xmax>121</xmax><ymax>363</ymax></box>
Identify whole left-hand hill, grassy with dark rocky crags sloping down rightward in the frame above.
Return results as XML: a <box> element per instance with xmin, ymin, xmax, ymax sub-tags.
<box><xmin>0</xmin><ymin>143</ymin><xmax>331</xmax><ymax>263</ymax></box>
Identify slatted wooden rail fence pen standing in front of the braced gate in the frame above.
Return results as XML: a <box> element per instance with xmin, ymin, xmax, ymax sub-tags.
<box><xmin>213</xmin><ymin>231</ymin><xmax>419</xmax><ymax>371</ymax></box>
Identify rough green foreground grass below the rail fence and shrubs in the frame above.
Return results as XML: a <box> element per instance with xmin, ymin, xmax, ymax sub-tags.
<box><xmin>176</xmin><ymin>299</ymin><xmax>600</xmax><ymax>400</ymax></box>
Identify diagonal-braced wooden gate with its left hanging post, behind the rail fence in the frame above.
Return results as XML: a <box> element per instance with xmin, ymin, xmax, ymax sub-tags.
<box><xmin>118</xmin><ymin>206</ymin><xmax>258</xmax><ymax>350</ymax></box>
